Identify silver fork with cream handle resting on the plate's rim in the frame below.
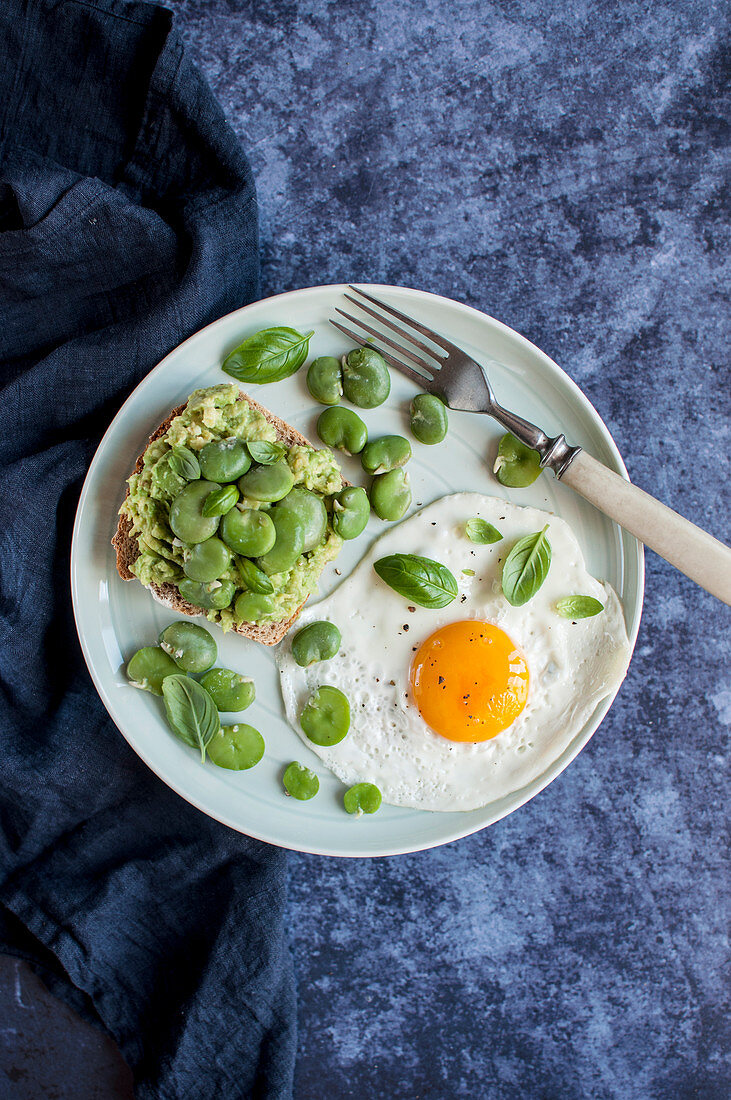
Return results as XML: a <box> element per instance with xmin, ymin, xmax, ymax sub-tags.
<box><xmin>331</xmin><ymin>286</ymin><xmax>731</xmax><ymax>604</ymax></box>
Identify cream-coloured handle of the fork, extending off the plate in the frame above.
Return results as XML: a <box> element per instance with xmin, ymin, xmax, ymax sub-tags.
<box><xmin>561</xmin><ymin>451</ymin><xmax>731</xmax><ymax>604</ymax></box>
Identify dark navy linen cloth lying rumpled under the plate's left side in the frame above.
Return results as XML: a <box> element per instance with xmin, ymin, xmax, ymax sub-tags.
<box><xmin>0</xmin><ymin>0</ymin><xmax>295</xmax><ymax>1100</ymax></box>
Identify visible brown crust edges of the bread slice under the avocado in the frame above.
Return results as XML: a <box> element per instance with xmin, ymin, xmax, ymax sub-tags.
<box><xmin>112</xmin><ymin>392</ymin><xmax>338</xmax><ymax>646</ymax></box>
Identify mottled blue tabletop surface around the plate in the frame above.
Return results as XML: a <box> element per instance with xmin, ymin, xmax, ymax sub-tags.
<box><xmin>174</xmin><ymin>0</ymin><xmax>731</xmax><ymax>1100</ymax></box>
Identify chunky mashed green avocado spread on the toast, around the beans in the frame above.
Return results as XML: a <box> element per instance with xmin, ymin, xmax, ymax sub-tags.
<box><xmin>120</xmin><ymin>384</ymin><xmax>343</xmax><ymax>630</ymax></box>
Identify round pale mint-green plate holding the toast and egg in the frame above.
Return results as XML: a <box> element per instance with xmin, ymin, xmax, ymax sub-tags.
<box><xmin>71</xmin><ymin>286</ymin><xmax>644</xmax><ymax>856</ymax></box>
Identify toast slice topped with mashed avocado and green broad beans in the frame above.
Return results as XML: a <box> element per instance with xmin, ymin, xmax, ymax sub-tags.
<box><xmin>112</xmin><ymin>384</ymin><xmax>346</xmax><ymax>646</ymax></box>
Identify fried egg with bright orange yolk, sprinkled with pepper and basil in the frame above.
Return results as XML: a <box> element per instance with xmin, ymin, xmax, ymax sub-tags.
<box><xmin>277</xmin><ymin>493</ymin><xmax>630</xmax><ymax>811</ymax></box>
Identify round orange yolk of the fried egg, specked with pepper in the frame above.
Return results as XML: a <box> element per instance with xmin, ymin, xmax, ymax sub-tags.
<box><xmin>411</xmin><ymin>620</ymin><xmax>528</xmax><ymax>741</ymax></box>
